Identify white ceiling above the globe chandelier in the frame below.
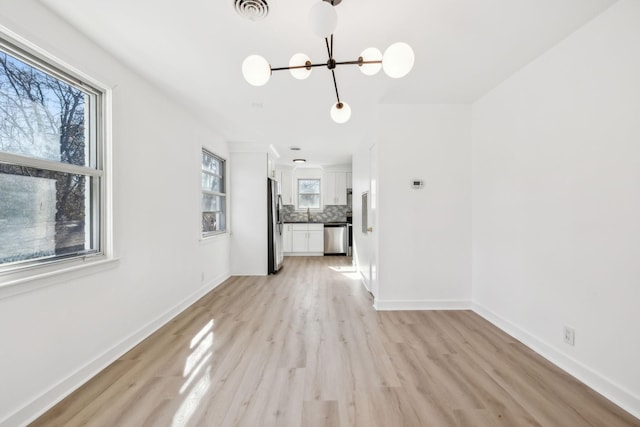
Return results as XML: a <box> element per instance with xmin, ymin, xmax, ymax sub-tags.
<box><xmin>41</xmin><ymin>0</ymin><xmax>615</xmax><ymax>165</ymax></box>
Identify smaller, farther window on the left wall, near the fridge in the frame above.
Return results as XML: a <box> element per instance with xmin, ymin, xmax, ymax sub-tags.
<box><xmin>202</xmin><ymin>149</ymin><xmax>227</xmax><ymax>237</ymax></box>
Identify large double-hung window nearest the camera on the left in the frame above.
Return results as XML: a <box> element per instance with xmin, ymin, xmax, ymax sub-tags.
<box><xmin>0</xmin><ymin>39</ymin><xmax>105</xmax><ymax>271</ymax></box>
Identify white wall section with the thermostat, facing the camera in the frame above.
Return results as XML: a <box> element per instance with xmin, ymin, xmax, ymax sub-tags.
<box><xmin>354</xmin><ymin>105</ymin><xmax>471</xmax><ymax>310</ymax></box>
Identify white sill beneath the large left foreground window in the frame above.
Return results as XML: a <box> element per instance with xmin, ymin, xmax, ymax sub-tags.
<box><xmin>0</xmin><ymin>256</ymin><xmax>119</xmax><ymax>300</ymax></box>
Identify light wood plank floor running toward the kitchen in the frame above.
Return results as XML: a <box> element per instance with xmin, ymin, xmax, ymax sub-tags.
<box><xmin>33</xmin><ymin>257</ymin><xmax>640</xmax><ymax>427</ymax></box>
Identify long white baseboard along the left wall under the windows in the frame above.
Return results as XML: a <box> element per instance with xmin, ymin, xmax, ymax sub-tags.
<box><xmin>0</xmin><ymin>273</ymin><xmax>231</xmax><ymax>427</ymax></box>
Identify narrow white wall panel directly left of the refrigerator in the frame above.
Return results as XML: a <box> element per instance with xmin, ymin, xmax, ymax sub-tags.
<box><xmin>230</xmin><ymin>152</ymin><xmax>268</xmax><ymax>276</ymax></box>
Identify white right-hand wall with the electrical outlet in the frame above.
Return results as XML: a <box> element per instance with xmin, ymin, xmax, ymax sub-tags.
<box><xmin>473</xmin><ymin>0</ymin><xmax>640</xmax><ymax>416</ymax></box>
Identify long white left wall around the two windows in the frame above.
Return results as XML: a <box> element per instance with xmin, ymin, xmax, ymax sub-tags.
<box><xmin>0</xmin><ymin>0</ymin><xmax>229</xmax><ymax>426</ymax></box>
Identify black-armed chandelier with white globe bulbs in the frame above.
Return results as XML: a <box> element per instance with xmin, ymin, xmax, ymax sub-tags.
<box><xmin>242</xmin><ymin>0</ymin><xmax>415</xmax><ymax>123</ymax></box>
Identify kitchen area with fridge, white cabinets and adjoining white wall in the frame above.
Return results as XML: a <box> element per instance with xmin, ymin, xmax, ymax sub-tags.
<box><xmin>228</xmin><ymin>149</ymin><xmax>353</xmax><ymax>276</ymax></box>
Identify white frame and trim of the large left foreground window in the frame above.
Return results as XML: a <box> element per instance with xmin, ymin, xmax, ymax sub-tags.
<box><xmin>0</xmin><ymin>27</ymin><xmax>109</xmax><ymax>280</ymax></box>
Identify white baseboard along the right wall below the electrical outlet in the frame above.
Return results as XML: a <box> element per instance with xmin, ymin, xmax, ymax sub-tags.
<box><xmin>472</xmin><ymin>302</ymin><xmax>640</xmax><ymax>418</ymax></box>
